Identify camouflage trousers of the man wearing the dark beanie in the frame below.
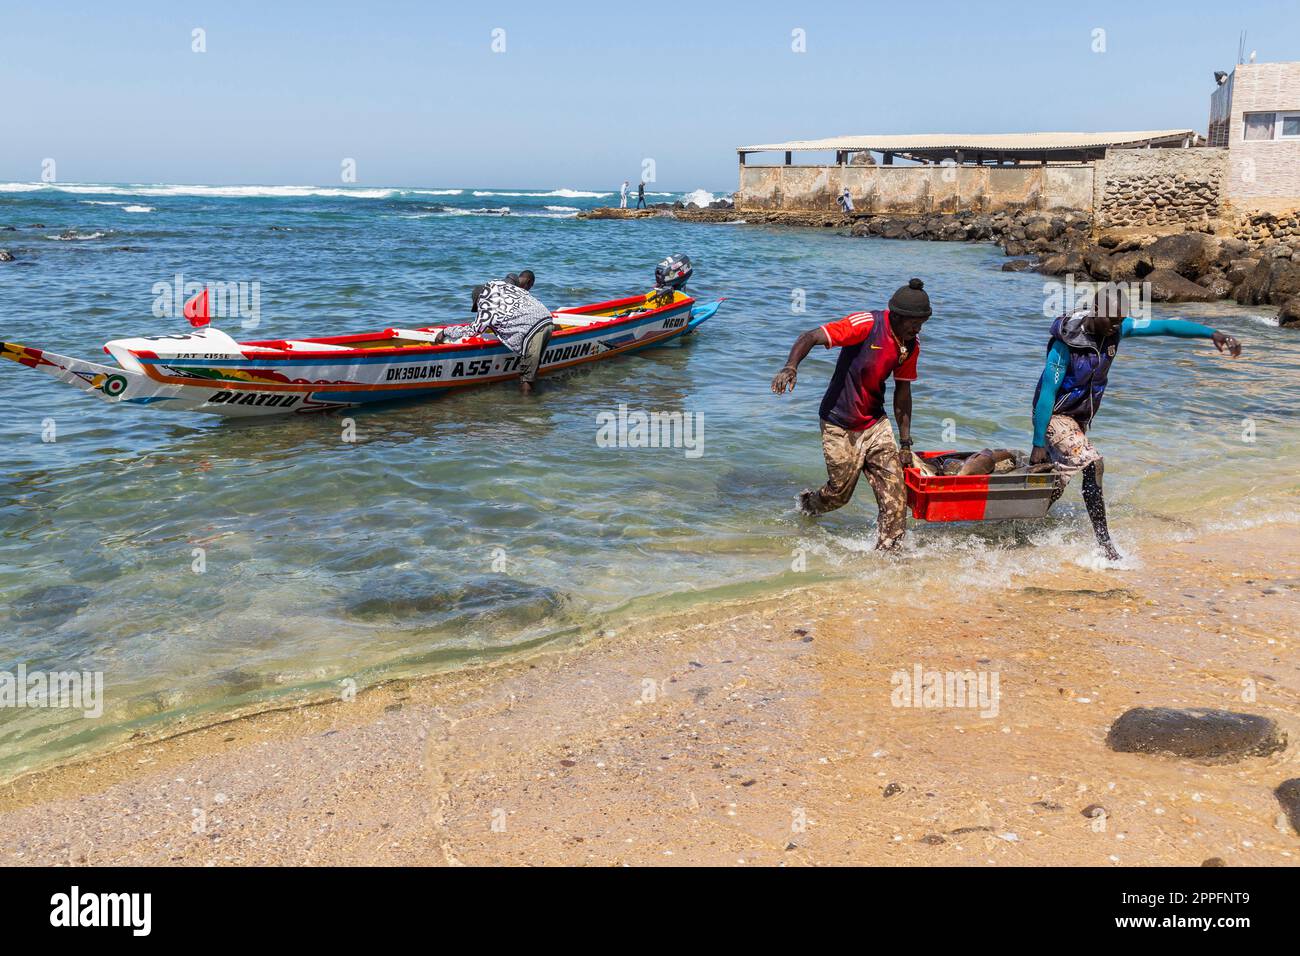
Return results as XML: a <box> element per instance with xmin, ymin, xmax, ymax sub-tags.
<box><xmin>803</xmin><ymin>419</ymin><xmax>907</xmax><ymax>548</ymax></box>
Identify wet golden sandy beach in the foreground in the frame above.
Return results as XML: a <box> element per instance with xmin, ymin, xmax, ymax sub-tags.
<box><xmin>0</xmin><ymin>524</ymin><xmax>1300</xmax><ymax>866</ymax></box>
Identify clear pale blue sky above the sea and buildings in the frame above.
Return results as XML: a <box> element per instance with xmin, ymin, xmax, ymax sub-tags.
<box><xmin>0</xmin><ymin>0</ymin><xmax>1300</xmax><ymax>191</ymax></box>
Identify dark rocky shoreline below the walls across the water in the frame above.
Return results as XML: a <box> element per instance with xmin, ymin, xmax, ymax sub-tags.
<box><xmin>579</xmin><ymin>200</ymin><xmax>1300</xmax><ymax>328</ymax></box>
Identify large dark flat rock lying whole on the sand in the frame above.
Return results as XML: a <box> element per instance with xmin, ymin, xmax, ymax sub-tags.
<box><xmin>1106</xmin><ymin>708</ymin><xmax>1287</xmax><ymax>762</ymax></box>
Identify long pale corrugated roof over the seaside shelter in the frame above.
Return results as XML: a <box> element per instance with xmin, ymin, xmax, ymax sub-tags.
<box><xmin>736</xmin><ymin>130</ymin><xmax>1196</xmax><ymax>152</ymax></box>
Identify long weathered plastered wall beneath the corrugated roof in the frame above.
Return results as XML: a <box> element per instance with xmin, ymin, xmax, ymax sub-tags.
<box><xmin>736</xmin><ymin>165</ymin><xmax>1093</xmax><ymax>216</ymax></box>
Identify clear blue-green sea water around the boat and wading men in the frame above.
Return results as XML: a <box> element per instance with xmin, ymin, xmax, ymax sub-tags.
<box><xmin>0</xmin><ymin>185</ymin><xmax>1300</xmax><ymax>777</ymax></box>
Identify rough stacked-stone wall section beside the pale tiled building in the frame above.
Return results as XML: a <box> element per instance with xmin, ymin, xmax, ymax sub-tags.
<box><xmin>1093</xmin><ymin>147</ymin><xmax>1227</xmax><ymax>229</ymax></box>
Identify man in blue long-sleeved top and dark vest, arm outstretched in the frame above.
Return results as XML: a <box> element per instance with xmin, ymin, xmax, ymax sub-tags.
<box><xmin>1030</xmin><ymin>284</ymin><xmax>1242</xmax><ymax>561</ymax></box>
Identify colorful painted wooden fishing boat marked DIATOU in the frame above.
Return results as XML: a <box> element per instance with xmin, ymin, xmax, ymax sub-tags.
<box><xmin>0</xmin><ymin>289</ymin><xmax>720</xmax><ymax>418</ymax></box>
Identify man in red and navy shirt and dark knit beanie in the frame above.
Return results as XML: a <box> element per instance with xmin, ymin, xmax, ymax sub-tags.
<box><xmin>772</xmin><ymin>278</ymin><xmax>931</xmax><ymax>549</ymax></box>
